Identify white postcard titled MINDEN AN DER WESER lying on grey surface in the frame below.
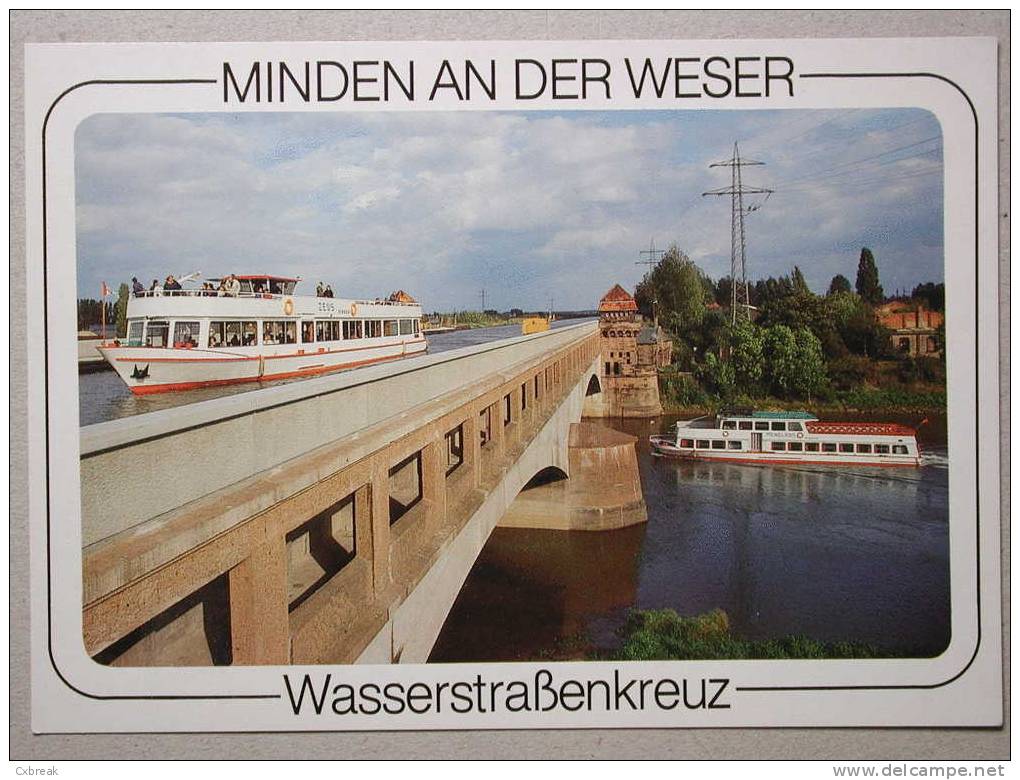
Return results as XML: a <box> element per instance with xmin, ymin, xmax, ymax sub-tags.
<box><xmin>24</xmin><ymin>38</ymin><xmax>1003</xmax><ymax>733</ymax></box>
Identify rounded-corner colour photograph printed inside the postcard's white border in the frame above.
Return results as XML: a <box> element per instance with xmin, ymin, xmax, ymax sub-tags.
<box><xmin>75</xmin><ymin>108</ymin><xmax>950</xmax><ymax>668</ymax></box>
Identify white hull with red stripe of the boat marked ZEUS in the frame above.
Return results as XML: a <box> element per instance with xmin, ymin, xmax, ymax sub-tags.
<box><xmin>98</xmin><ymin>337</ymin><xmax>427</xmax><ymax>396</ymax></box>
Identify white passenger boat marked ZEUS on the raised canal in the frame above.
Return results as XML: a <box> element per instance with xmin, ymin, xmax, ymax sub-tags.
<box><xmin>98</xmin><ymin>274</ymin><xmax>427</xmax><ymax>395</ymax></box>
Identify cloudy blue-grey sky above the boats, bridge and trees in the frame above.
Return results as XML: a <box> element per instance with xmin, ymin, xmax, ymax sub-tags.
<box><xmin>75</xmin><ymin>109</ymin><xmax>944</xmax><ymax>311</ymax></box>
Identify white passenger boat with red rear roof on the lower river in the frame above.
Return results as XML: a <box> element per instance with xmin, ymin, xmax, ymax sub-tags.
<box><xmin>650</xmin><ymin>409</ymin><xmax>921</xmax><ymax>466</ymax></box>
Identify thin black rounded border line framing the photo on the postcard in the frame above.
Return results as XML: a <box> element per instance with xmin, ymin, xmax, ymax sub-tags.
<box><xmin>42</xmin><ymin>72</ymin><xmax>981</xmax><ymax>705</ymax></box>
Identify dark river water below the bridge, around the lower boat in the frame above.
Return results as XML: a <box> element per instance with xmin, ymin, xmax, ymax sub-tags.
<box><xmin>429</xmin><ymin>415</ymin><xmax>950</xmax><ymax>662</ymax></box>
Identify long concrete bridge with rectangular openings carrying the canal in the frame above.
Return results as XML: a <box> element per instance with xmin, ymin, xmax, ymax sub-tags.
<box><xmin>81</xmin><ymin>322</ymin><xmax>601</xmax><ymax>666</ymax></box>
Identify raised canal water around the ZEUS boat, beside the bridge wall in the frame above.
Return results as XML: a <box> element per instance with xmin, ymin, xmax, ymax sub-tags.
<box><xmin>78</xmin><ymin>319</ymin><xmax>582</xmax><ymax>425</ymax></box>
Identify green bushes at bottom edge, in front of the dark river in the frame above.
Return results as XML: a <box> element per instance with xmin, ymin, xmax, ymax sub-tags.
<box><xmin>611</xmin><ymin>610</ymin><xmax>887</xmax><ymax>661</ymax></box>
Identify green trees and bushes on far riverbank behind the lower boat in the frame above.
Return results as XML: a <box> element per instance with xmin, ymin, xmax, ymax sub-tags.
<box><xmin>634</xmin><ymin>245</ymin><xmax>946</xmax><ymax>412</ymax></box>
